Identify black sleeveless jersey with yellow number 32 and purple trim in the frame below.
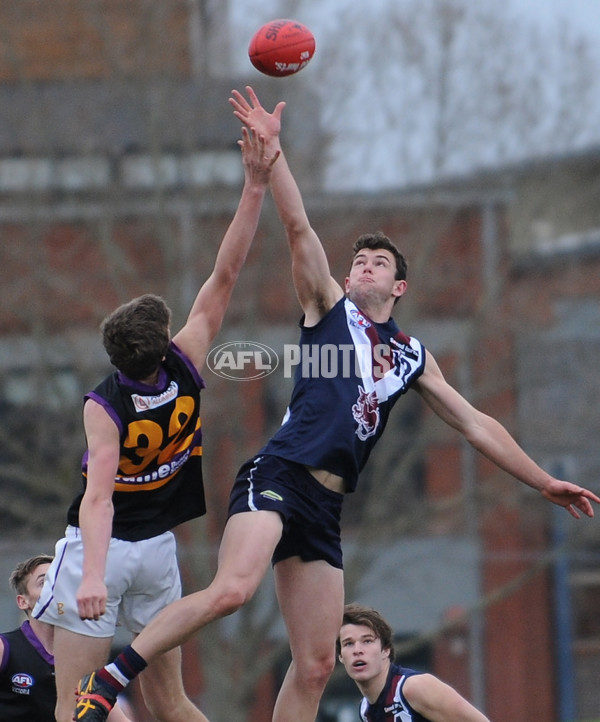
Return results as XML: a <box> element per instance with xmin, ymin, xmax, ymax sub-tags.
<box><xmin>67</xmin><ymin>343</ymin><xmax>206</xmax><ymax>541</ymax></box>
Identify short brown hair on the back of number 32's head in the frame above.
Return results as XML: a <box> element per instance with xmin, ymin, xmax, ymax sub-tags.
<box><xmin>100</xmin><ymin>293</ymin><xmax>171</xmax><ymax>381</ymax></box>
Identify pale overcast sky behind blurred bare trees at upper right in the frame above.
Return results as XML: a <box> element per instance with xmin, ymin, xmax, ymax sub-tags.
<box><xmin>231</xmin><ymin>0</ymin><xmax>600</xmax><ymax>190</ymax></box>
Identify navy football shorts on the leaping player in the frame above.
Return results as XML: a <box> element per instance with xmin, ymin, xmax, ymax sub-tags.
<box><xmin>228</xmin><ymin>455</ymin><xmax>344</xmax><ymax>569</ymax></box>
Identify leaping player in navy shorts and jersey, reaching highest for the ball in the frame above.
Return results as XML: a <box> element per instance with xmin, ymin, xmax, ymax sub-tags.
<box><xmin>72</xmin><ymin>88</ymin><xmax>600</xmax><ymax>722</ymax></box>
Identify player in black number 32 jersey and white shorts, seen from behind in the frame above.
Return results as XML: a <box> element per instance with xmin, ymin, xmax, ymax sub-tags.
<box><xmin>34</xmin><ymin>119</ymin><xmax>277</xmax><ymax>722</ymax></box>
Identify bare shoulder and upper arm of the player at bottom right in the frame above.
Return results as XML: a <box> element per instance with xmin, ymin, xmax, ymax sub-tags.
<box><xmin>402</xmin><ymin>674</ymin><xmax>489</xmax><ymax>722</ymax></box>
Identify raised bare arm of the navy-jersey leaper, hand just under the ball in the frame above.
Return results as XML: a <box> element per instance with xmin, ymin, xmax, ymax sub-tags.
<box><xmin>230</xmin><ymin>86</ymin><xmax>343</xmax><ymax>326</ymax></box>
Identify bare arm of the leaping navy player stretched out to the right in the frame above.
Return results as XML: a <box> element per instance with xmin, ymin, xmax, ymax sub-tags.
<box><xmin>415</xmin><ymin>352</ymin><xmax>600</xmax><ymax>519</ymax></box>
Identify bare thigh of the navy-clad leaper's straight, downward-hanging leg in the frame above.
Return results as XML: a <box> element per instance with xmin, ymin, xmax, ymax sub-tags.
<box><xmin>274</xmin><ymin>557</ymin><xmax>344</xmax><ymax>660</ymax></box>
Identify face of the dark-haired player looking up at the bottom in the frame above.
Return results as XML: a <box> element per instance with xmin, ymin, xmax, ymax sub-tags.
<box><xmin>340</xmin><ymin>624</ymin><xmax>390</xmax><ymax>682</ymax></box>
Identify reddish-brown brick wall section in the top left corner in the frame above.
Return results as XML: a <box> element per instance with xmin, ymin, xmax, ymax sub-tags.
<box><xmin>0</xmin><ymin>0</ymin><xmax>190</xmax><ymax>82</ymax></box>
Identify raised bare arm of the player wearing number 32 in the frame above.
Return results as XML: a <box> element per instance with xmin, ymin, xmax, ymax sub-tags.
<box><xmin>173</xmin><ymin>128</ymin><xmax>279</xmax><ymax>371</ymax></box>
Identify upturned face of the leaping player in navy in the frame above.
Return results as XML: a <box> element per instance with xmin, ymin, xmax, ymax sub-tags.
<box><xmin>346</xmin><ymin>248</ymin><xmax>406</xmax><ymax>307</ymax></box>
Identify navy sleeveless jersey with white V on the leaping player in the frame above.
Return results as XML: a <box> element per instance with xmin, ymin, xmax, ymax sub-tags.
<box><xmin>260</xmin><ymin>298</ymin><xmax>425</xmax><ymax>492</ymax></box>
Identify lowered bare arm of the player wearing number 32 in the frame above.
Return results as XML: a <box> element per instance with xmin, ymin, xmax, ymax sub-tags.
<box><xmin>77</xmin><ymin>399</ymin><xmax>119</xmax><ymax>619</ymax></box>
